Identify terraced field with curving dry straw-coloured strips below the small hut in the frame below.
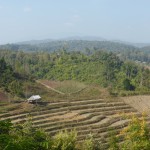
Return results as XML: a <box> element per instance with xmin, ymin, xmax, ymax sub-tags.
<box><xmin>0</xmin><ymin>96</ymin><xmax>149</xmax><ymax>146</ymax></box>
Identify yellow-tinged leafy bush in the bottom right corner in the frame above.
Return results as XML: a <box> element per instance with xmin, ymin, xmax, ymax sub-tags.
<box><xmin>121</xmin><ymin>115</ymin><xmax>150</xmax><ymax>150</ymax></box>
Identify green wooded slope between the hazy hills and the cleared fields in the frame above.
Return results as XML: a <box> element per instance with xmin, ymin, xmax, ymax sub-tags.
<box><xmin>0</xmin><ymin>50</ymin><xmax>150</xmax><ymax>96</ymax></box>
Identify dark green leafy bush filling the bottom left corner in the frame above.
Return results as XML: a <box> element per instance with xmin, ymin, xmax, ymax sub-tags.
<box><xmin>0</xmin><ymin>120</ymin><xmax>52</xmax><ymax>150</ymax></box>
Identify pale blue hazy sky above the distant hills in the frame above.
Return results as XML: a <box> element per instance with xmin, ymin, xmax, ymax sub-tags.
<box><xmin>0</xmin><ymin>0</ymin><xmax>150</xmax><ymax>44</ymax></box>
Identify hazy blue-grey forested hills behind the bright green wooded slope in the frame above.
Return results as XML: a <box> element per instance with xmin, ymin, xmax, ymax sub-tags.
<box><xmin>0</xmin><ymin>40</ymin><xmax>150</xmax><ymax>64</ymax></box>
